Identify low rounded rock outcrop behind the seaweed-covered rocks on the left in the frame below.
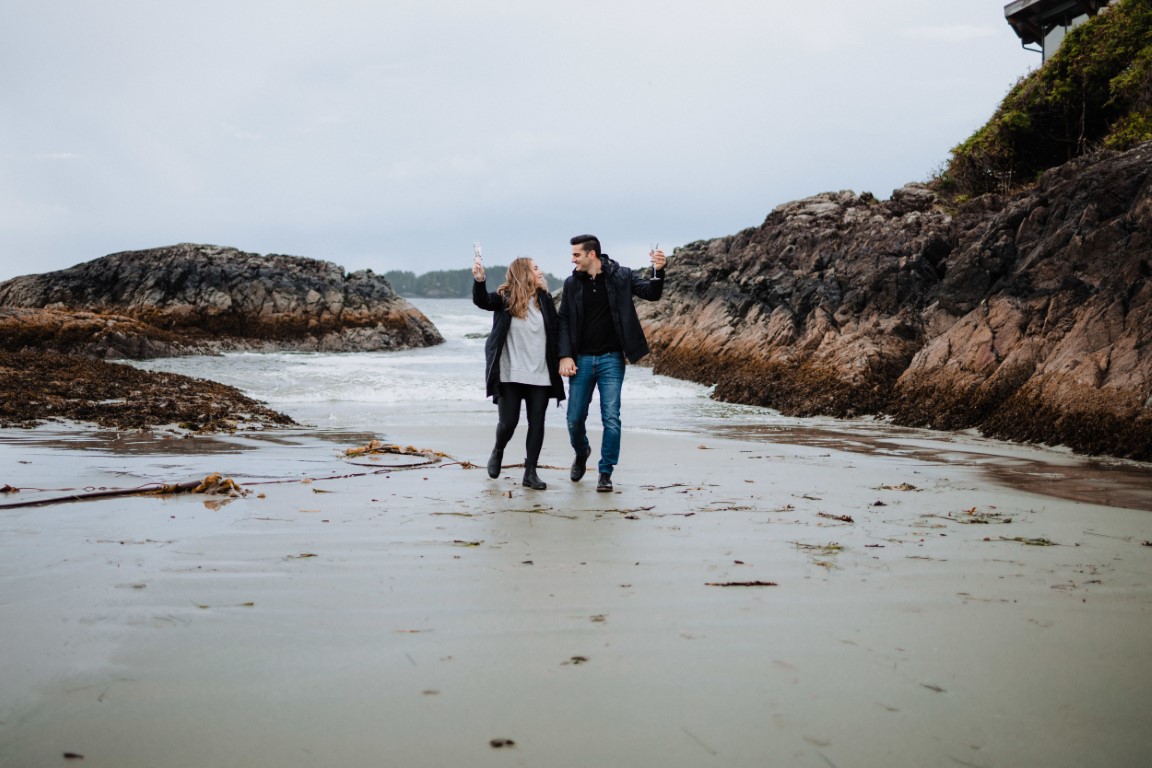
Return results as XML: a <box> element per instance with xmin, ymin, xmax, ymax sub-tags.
<box><xmin>0</xmin><ymin>243</ymin><xmax>444</xmax><ymax>357</ymax></box>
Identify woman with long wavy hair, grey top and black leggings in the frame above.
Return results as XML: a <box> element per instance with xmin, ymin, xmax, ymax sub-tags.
<box><xmin>472</xmin><ymin>257</ymin><xmax>564</xmax><ymax>491</ymax></box>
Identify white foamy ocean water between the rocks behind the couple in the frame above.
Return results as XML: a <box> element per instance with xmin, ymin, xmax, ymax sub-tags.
<box><xmin>132</xmin><ymin>298</ymin><xmax>795</xmax><ymax>431</ymax></box>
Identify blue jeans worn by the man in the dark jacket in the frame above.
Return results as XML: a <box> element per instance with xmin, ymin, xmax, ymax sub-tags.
<box><xmin>568</xmin><ymin>352</ymin><xmax>624</xmax><ymax>476</ymax></box>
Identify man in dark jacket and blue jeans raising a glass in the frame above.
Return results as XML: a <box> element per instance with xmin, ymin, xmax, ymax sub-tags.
<box><xmin>559</xmin><ymin>235</ymin><xmax>666</xmax><ymax>493</ymax></box>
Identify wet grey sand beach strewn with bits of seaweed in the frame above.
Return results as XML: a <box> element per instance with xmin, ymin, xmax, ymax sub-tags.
<box><xmin>0</xmin><ymin>425</ymin><xmax>1152</xmax><ymax>768</ymax></box>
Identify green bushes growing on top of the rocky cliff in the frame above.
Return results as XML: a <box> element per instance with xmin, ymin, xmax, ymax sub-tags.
<box><xmin>937</xmin><ymin>0</ymin><xmax>1152</xmax><ymax>196</ymax></box>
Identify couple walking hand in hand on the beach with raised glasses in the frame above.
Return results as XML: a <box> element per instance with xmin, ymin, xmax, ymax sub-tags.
<box><xmin>472</xmin><ymin>235</ymin><xmax>666</xmax><ymax>493</ymax></box>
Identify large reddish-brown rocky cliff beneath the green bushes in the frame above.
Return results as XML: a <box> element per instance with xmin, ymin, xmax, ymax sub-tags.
<box><xmin>642</xmin><ymin>144</ymin><xmax>1152</xmax><ymax>459</ymax></box>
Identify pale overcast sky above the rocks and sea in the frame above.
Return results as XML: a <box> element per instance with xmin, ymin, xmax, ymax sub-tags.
<box><xmin>0</xmin><ymin>0</ymin><xmax>1040</xmax><ymax>280</ymax></box>
